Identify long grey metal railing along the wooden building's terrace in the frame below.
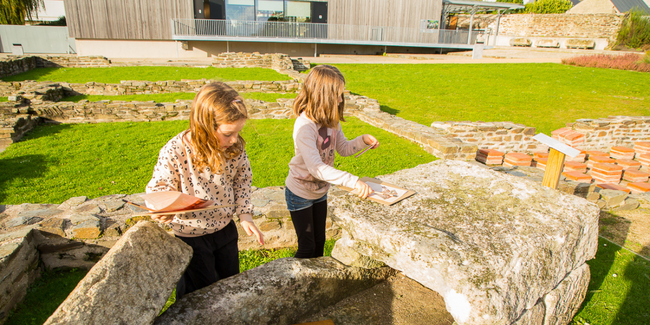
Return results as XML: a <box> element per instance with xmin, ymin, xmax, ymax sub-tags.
<box><xmin>172</xmin><ymin>19</ymin><xmax>481</xmax><ymax>44</ymax></box>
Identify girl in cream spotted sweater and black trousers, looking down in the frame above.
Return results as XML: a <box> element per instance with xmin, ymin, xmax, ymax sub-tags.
<box><xmin>146</xmin><ymin>82</ymin><xmax>264</xmax><ymax>299</ymax></box>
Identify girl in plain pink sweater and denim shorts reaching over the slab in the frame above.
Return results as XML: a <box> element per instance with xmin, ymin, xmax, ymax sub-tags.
<box><xmin>285</xmin><ymin>65</ymin><xmax>379</xmax><ymax>258</ymax></box>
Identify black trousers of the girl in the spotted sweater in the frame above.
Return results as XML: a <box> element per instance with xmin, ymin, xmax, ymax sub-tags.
<box><xmin>176</xmin><ymin>221</ymin><xmax>239</xmax><ymax>299</ymax></box>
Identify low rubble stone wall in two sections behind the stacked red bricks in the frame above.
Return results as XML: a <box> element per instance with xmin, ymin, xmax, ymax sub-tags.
<box><xmin>431</xmin><ymin>116</ymin><xmax>650</xmax><ymax>154</ymax></box>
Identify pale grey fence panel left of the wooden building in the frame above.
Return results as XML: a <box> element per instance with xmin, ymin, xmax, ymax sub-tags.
<box><xmin>0</xmin><ymin>25</ymin><xmax>77</xmax><ymax>54</ymax></box>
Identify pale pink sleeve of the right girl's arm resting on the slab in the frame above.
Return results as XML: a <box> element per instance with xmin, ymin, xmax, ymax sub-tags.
<box><xmin>294</xmin><ymin>123</ymin><xmax>359</xmax><ymax>188</ymax></box>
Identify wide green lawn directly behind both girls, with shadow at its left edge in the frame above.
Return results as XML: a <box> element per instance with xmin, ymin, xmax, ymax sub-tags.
<box><xmin>0</xmin><ymin>118</ymin><xmax>435</xmax><ymax>204</ymax></box>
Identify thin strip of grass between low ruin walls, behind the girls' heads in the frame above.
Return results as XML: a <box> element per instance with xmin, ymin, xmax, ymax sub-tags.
<box><xmin>60</xmin><ymin>92</ymin><xmax>297</xmax><ymax>103</ymax></box>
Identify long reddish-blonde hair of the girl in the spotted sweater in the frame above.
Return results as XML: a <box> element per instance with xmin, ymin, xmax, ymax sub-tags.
<box><xmin>186</xmin><ymin>82</ymin><xmax>248</xmax><ymax>174</ymax></box>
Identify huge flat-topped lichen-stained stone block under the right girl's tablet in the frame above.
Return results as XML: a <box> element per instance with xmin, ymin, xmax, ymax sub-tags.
<box><xmin>330</xmin><ymin>160</ymin><xmax>599</xmax><ymax>324</ymax></box>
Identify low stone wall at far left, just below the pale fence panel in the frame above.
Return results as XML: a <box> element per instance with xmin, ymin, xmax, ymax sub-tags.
<box><xmin>0</xmin><ymin>55</ymin><xmax>111</xmax><ymax>78</ymax></box>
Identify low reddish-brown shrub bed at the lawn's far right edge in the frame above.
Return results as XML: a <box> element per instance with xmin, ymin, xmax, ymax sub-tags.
<box><xmin>562</xmin><ymin>52</ymin><xmax>650</xmax><ymax>72</ymax></box>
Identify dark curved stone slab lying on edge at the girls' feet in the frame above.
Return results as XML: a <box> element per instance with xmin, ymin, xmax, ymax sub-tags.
<box><xmin>155</xmin><ymin>257</ymin><xmax>396</xmax><ymax>325</ymax></box>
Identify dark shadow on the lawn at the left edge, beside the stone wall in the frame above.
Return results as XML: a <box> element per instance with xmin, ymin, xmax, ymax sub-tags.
<box><xmin>0</xmin><ymin>154</ymin><xmax>47</xmax><ymax>202</ymax></box>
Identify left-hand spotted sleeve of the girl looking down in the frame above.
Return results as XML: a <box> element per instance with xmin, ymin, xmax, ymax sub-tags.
<box><xmin>145</xmin><ymin>145</ymin><xmax>180</xmax><ymax>193</ymax></box>
